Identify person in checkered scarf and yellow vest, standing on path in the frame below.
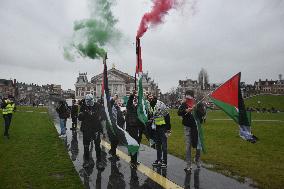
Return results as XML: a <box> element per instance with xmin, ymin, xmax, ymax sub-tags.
<box><xmin>148</xmin><ymin>95</ymin><xmax>171</xmax><ymax>168</ymax></box>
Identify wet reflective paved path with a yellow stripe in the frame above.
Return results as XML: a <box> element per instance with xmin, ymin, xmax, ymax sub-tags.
<box><xmin>50</xmin><ymin>106</ymin><xmax>253</xmax><ymax>189</ymax></box>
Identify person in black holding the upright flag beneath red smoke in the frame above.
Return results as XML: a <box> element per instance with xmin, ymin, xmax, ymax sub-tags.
<box><xmin>125</xmin><ymin>91</ymin><xmax>144</xmax><ymax>168</ymax></box>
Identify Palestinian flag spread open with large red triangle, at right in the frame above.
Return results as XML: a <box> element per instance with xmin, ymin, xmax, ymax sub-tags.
<box><xmin>210</xmin><ymin>72</ymin><xmax>257</xmax><ymax>143</ymax></box>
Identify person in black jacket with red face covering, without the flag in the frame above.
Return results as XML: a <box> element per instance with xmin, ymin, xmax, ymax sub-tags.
<box><xmin>178</xmin><ymin>90</ymin><xmax>202</xmax><ymax>172</ymax></box>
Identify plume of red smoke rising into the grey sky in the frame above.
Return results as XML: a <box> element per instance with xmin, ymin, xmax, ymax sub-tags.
<box><xmin>136</xmin><ymin>0</ymin><xmax>177</xmax><ymax>38</ymax></box>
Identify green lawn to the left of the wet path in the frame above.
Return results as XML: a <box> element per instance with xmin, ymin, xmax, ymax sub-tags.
<box><xmin>0</xmin><ymin>107</ymin><xmax>83</xmax><ymax>188</ymax></box>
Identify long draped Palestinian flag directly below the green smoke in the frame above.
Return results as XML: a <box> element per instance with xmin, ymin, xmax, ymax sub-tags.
<box><xmin>102</xmin><ymin>58</ymin><xmax>139</xmax><ymax>155</ymax></box>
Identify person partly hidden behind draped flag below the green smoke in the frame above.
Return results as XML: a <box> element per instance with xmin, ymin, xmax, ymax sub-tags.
<box><xmin>109</xmin><ymin>94</ymin><xmax>125</xmax><ymax>159</ymax></box>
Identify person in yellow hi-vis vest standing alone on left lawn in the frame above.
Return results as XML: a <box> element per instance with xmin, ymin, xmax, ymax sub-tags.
<box><xmin>1</xmin><ymin>95</ymin><xmax>16</xmax><ymax>139</ymax></box>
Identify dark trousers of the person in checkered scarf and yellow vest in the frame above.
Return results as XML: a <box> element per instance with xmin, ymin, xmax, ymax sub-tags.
<box><xmin>154</xmin><ymin>126</ymin><xmax>168</xmax><ymax>163</ymax></box>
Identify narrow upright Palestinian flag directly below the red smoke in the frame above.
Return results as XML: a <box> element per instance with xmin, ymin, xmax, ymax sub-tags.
<box><xmin>136</xmin><ymin>38</ymin><xmax>148</xmax><ymax>125</ymax></box>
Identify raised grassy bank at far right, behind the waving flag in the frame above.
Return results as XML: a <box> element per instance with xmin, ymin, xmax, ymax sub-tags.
<box><xmin>245</xmin><ymin>95</ymin><xmax>284</xmax><ymax>112</ymax></box>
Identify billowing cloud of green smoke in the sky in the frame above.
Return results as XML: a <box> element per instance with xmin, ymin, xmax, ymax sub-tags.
<box><xmin>63</xmin><ymin>0</ymin><xmax>121</xmax><ymax>61</ymax></box>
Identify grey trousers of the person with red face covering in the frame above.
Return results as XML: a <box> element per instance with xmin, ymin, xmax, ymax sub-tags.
<box><xmin>184</xmin><ymin>126</ymin><xmax>200</xmax><ymax>167</ymax></box>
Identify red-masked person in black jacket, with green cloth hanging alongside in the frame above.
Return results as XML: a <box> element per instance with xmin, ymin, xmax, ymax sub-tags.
<box><xmin>178</xmin><ymin>90</ymin><xmax>205</xmax><ymax>172</ymax></box>
